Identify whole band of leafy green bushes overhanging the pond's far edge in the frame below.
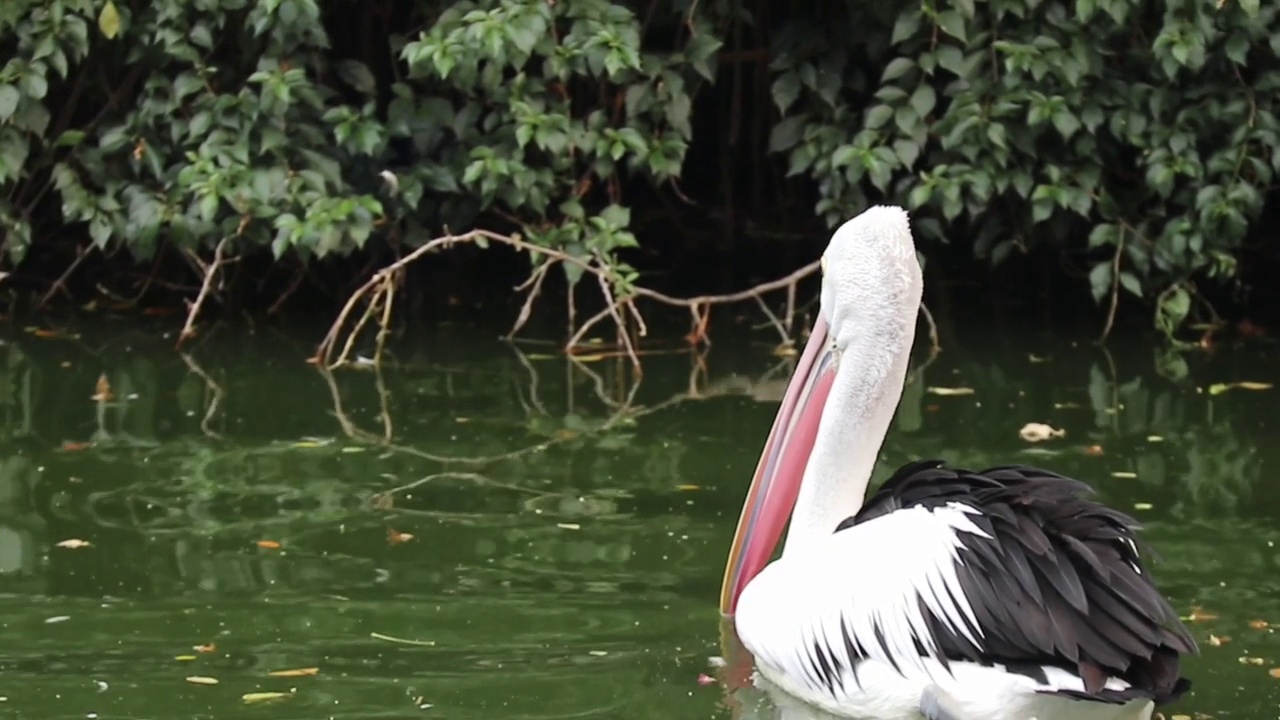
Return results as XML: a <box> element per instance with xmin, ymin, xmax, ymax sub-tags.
<box><xmin>0</xmin><ymin>0</ymin><xmax>1280</xmax><ymax>333</ymax></box>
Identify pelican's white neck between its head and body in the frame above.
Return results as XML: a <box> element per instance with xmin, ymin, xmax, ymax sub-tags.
<box><xmin>782</xmin><ymin>325</ymin><xmax>915</xmax><ymax>556</ymax></box>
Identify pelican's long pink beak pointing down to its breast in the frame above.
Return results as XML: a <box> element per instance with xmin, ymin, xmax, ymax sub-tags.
<box><xmin>721</xmin><ymin>315</ymin><xmax>838</xmax><ymax>616</ymax></box>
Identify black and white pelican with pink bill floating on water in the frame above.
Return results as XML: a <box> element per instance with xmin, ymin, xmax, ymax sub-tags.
<box><xmin>721</xmin><ymin>206</ymin><xmax>1197</xmax><ymax>720</ymax></box>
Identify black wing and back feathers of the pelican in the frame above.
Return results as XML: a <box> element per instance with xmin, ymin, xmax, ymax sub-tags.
<box><xmin>837</xmin><ymin>460</ymin><xmax>1197</xmax><ymax>702</ymax></box>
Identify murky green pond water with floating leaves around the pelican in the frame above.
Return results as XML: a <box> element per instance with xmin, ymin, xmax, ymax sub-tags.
<box><xmin>0</xmin><ymin>326</ymin><xmax>1280</xmax><ymax>720</ymax></box>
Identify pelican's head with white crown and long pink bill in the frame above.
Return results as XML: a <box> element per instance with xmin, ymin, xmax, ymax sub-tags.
<box><xmin>721</xmin><ymin>205</ymin><xmax>924</xmax><ymax>615</ymax></box>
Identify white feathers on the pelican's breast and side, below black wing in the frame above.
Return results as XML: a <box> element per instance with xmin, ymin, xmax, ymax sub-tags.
<box><xmin>735</xmin><ymin>503</ymin><xmax>991</xmax><ymax>691</ymax></box>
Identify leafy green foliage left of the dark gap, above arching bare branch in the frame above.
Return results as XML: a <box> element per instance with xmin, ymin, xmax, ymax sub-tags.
<box><xmin>0</xmin><ymin>0</ymin><xmax>721</xmax><ymax>290</ymax></box>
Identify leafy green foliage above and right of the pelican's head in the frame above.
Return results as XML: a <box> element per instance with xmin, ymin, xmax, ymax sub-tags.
<box><xmin>771</xmin><ymin>0</ymin><xmax>1280</xmax><ymax>333</ymax></box>
